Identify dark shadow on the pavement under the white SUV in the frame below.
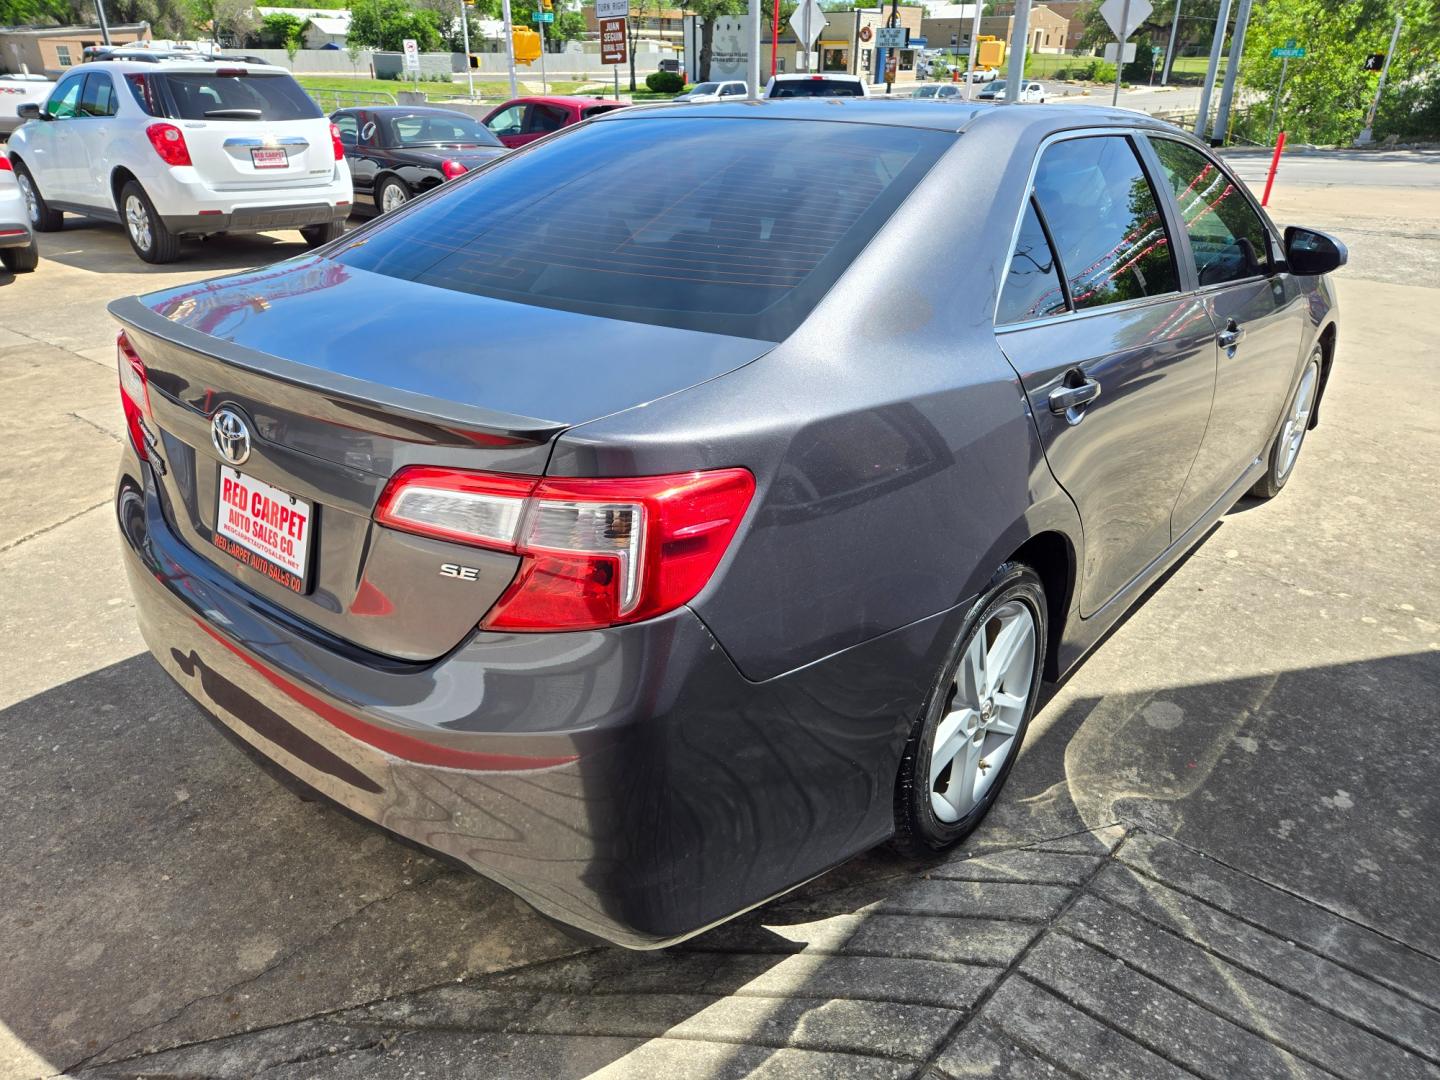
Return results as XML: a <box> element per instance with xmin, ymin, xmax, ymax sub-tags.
<box><xmin>33</xmin><ymin>217</ymin><xmax>321</xmax><ymax>281</ymax></box>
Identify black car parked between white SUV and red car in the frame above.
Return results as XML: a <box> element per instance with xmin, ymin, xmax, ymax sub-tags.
<box><xmin>330</xmin><ymin>105</ymin><xmax>508</xmax><ymax>213</ymax></box>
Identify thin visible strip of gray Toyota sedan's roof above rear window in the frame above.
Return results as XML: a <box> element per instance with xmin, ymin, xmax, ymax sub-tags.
<box><xmin>592</xmin><ymin>96</ymin><xmax>1179</xmax><ymax>135</ymax></box>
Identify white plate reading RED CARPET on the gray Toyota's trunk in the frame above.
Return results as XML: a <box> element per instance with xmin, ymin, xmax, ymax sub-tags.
<box><xmin>213</xmin><ymin>464</ymin><xmax>315</xmax><ymax>595</ymax></box>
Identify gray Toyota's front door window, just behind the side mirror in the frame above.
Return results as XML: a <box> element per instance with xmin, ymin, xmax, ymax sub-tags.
<box><xmin>1151</xmin><ymin>138</ymin><xmax>1269</xmax><ymax>285</ymax></box>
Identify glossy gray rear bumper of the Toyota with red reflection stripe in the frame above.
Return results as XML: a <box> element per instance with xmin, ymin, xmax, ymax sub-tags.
<box><xmin>117</xmin><ymin>446</ymin><xmax>958</xmax><ymax>948</ymax></box>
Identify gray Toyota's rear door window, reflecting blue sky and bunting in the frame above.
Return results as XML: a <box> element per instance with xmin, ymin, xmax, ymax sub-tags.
<box><xmin>1035</xmin><ymin>135</ymin><xmax>1179</xmax><ymax>308</ymax></box>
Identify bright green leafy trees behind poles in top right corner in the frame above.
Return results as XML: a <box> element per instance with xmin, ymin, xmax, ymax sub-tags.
<box><xmin>1240</xmin><ymin>0</ymin><xmax>1440</xmax><ymax>144</ymax></box>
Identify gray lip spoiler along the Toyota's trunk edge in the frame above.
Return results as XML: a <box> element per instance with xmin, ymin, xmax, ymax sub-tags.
<box><xmin>105</xmin><ymin>297</ymin><xmax>570</xmax><ymax>444</ymax></box>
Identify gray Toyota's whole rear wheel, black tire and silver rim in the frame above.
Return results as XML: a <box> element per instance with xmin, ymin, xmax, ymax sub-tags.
<box><xmin>894</xmin><ymin>563</ymin><xmax>1045</xmax><ymax>857</ymax></box>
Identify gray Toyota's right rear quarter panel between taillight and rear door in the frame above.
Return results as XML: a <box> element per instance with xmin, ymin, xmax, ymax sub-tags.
<box><xmin>549</xmin><ymin>116</ymin><xmax>1080</xmax><ymax>680</ymax></box>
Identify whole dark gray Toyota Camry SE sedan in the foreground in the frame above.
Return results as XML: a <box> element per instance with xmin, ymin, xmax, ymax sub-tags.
<box><xmin>111</xmin><ymin>99</ymin><xmax>1345</xmax><ymax>948</ymax></box>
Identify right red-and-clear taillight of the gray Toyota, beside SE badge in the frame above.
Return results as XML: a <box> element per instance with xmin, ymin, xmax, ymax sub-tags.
<box><xmin>374</xmin><ymin>465</ymin><xmax>755</xmax><ymax>631</ymax></box>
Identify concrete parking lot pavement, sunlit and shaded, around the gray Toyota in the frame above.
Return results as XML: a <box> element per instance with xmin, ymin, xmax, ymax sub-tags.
<box><xmin>0</xmin><ymin>151</ymin><xmax>1440</xmax><ymax>1080</ymax></box>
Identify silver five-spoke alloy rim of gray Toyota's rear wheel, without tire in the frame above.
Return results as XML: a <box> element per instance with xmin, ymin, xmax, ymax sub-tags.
<box><xmin>929</xmin><ymin>600</ymin><xmax>1035</xmax><ymax>822</ymax></box>
